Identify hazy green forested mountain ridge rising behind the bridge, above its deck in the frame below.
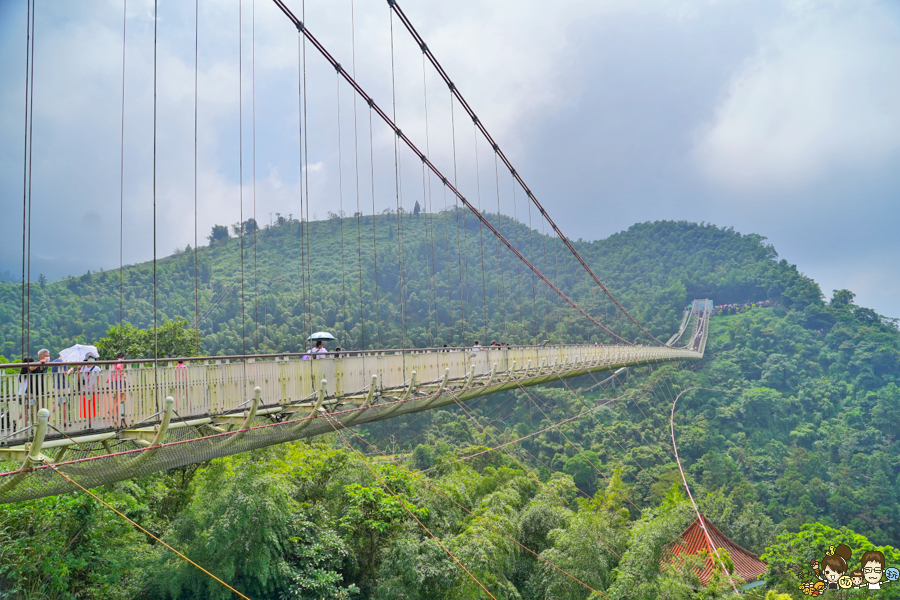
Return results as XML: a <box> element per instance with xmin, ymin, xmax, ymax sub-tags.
<box><xmin>0</xmin><ymin>211</ymin><xmax>820</xmax><ymax>357</ymax></box>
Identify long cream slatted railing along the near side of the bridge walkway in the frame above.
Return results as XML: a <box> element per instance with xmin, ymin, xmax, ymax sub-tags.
<box><xmin>0</xmin><ymin>344</ymin><xmax>697</xmax><ymax>445</ymax></box>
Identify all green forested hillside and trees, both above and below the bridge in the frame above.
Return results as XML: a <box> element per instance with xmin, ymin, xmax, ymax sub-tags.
<box><xmin>0</xmin><ymin>213</ymin><xmax>900</xmax><ymax>600</ymax></box>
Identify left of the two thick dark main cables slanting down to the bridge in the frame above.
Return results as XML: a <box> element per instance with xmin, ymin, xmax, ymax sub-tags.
<box><xmin>273</xmin><ymin>0</ymin><xmax>631</xmax><ymax>344</ymax></box>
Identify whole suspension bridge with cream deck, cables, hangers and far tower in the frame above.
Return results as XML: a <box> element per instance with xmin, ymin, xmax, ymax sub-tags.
<box><xmin>0</xmin><ymin>0</ymin><xmax>713</xmax><ymax>502</ymax></box>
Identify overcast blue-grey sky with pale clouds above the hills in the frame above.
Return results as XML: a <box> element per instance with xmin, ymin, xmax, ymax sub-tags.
<box><xmin>0</xmin><ymin>0</ymin><xmax>900</xmax><ymax>317</ymax></box>
